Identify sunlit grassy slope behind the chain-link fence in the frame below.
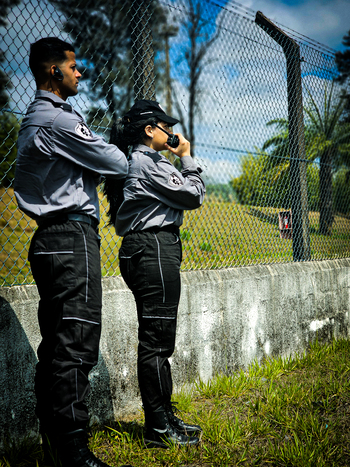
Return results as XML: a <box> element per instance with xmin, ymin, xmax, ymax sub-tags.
<box><xmin>0</xmin><ymin>188</ymin><xmax>350</xmax><ymax>286</ymax></box>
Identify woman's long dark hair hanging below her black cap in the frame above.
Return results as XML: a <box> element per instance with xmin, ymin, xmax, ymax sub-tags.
<box><xmin>103</xmin><ymin>117</ymin><xmax>158</xmax><ymax>225</ymax></box>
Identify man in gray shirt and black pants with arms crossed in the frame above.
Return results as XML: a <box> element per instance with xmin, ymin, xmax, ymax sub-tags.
<box><xmin>15</xmin><ymin>37</ymin><xmax>133</xmax><ymax>467</ymax></box>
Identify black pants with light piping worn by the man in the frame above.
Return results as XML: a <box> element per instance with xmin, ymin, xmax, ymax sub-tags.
<box><xmin>29</xmin><ymin>221</ymin><xmax>102</xmax><ymax>433</ymax></box>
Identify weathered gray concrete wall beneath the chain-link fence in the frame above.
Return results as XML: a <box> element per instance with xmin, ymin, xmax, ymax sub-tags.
<box><xmin>0</xmin><ymin>259</ymin><xmax>350</xmax><ymax>440</ymax></box>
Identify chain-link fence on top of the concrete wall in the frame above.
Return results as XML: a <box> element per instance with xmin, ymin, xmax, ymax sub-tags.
<box><xmin>0</xmin><ymin>0</ymin><xmax>350</xmax><ymax>285</ymax></box>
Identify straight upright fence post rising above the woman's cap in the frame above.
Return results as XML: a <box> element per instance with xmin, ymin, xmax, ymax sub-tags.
<box><xmin>130</xmin><ymin>0</ymin><xmax>155</xmax><ymax>100</ymax></box>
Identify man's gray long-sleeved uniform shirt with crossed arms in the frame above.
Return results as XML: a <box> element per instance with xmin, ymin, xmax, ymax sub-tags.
<box><xmin>14</xmin><ymin>90</ymin><xmax>128</xmax><ymax>224</ymax></box>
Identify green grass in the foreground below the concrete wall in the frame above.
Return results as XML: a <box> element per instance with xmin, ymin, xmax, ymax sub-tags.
<box><xmin>0</xmin><ymin>339</ymin><xmax>350</xmax><ymax>467</ymax></box>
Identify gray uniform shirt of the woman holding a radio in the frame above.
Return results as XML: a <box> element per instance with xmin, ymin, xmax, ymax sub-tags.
<box><xmin>115</xmin><ymin>144</ymin><xmax>205</xmax><ymax>236</ymax></box>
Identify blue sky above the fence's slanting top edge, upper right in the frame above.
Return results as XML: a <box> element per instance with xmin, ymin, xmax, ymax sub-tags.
<box><xmin>228</xmin><ymin>0</ymin><xmax>350</xmax><ymax>51</ymax></box>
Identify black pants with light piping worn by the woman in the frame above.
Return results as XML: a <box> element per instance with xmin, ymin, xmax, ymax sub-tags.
<box><xmin>119</xmin><ymin>230</ymin><xmax>182</xmax><ymax>414</ymax></box>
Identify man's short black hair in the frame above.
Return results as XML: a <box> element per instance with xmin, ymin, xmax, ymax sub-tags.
<box><xmin>29</xmin><ymin>37</ymin><xmax>74</xmax><ymax>81</ymax></box>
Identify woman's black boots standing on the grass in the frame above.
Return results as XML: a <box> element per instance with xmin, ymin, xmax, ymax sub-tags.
<box><xmin>144</xmin><ymin>407</ymin><xmax>199</xmax><ymax>448</ymax></box>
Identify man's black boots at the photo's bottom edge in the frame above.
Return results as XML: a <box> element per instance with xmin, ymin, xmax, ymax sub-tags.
<box><xmin>43</xmin><ymin>429</ymin><xmax>132</xmax><ymax>467</ymax></box>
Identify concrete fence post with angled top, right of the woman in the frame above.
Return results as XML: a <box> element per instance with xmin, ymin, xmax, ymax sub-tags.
<box><xmin>255</xmin><ymin>11</ymin><xmax>311</xmax><ymax>261</ymax></box>
